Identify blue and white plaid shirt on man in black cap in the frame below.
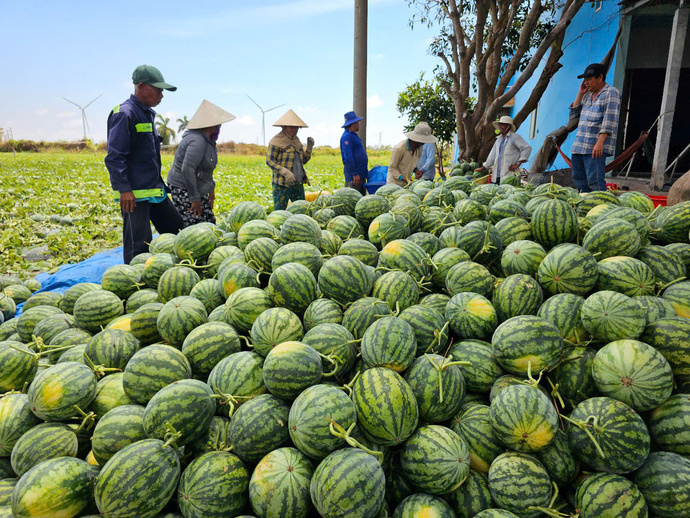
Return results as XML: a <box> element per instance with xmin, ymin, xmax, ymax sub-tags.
<box><xmin>570</xmin><ymin>84</ymin><xmax>621</xmax><ymax>156</ymax></box>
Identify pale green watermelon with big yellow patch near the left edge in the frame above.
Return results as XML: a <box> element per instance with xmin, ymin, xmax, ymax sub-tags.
<box><xmin>28</xmin><ymin>362</ymin><xmax>97</xmax><ymax>421</ymax></box>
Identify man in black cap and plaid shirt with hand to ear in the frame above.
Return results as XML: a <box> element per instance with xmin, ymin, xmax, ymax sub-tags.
<box><xmin>570</xmin><ymin>63</ymin><xmax>621</xmax><ymax>192</ymax></box>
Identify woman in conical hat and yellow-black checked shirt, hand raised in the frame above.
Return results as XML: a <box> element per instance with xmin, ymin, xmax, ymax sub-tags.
<box><xmin>266</xmin><ymin>110</ymin><xmax>314</xmax><ymax>210</ymax></box>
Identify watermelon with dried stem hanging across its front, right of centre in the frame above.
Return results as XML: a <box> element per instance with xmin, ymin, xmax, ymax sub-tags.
<box><xmin>404</xmin><ymin>356</ymin><xmax>465</xmax><ymax>423</ymax></box>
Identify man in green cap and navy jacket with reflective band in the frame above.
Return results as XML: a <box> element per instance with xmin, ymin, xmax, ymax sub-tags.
<box><xmin>105</xmin><ymin>65</ymin><xmax>183</xmax><ymax>264</ymax></box>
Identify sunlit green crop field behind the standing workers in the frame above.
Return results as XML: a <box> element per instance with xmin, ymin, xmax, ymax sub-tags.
<box><xmin>0</xmin><ymin>148</ymin><xmax>390</xmax><ymax>277</ymax></box>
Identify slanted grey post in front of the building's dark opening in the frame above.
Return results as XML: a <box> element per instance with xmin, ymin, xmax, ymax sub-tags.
<box><xmin>651</xmin><ymin>4</ymin><xmax>690</xmax><ymax>191</ymax></box>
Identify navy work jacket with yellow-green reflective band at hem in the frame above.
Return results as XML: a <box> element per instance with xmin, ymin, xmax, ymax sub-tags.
<box><xmin>105</xmin><ymin>95</ymin><xmax>164</xmax><ymax>199</ymax></box>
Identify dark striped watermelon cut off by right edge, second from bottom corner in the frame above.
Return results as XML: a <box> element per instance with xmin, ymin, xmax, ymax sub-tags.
<box><xmin>648</xmin><ymin>394</ymin><xmax>690</xmax><ymax>457</ymax></box>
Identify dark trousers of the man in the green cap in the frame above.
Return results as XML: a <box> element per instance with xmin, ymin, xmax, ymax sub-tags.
<box><xmin>122</xmin><ymin>197</ymin><xmax>184</xmax><ymax>264</ymax></box>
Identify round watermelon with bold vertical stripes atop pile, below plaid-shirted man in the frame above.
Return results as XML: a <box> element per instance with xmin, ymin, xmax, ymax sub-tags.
<box><xmin>531</xmin><ymin>199</ymin><xmax>578</xmax><ymax>248</ymax></box>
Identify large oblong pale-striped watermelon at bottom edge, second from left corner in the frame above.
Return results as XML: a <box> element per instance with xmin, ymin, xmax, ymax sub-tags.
<box><xmin>94</xmin><ymin>439</ymin><xmax>180</xmax><ymax>518</ymax></box>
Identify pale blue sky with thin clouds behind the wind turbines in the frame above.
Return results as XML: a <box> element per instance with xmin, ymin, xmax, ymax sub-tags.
<box><xmin>0</xmin><ymin>0</ymin><xmax>438</xmax><ymax>146</ymax></box>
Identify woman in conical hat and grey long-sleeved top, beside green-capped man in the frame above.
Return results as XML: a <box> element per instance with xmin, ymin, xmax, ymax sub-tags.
<box><xmin>167</xmin><ymin>99</ymin><xmax>235</xmax><ymax>227</ymax></box>
